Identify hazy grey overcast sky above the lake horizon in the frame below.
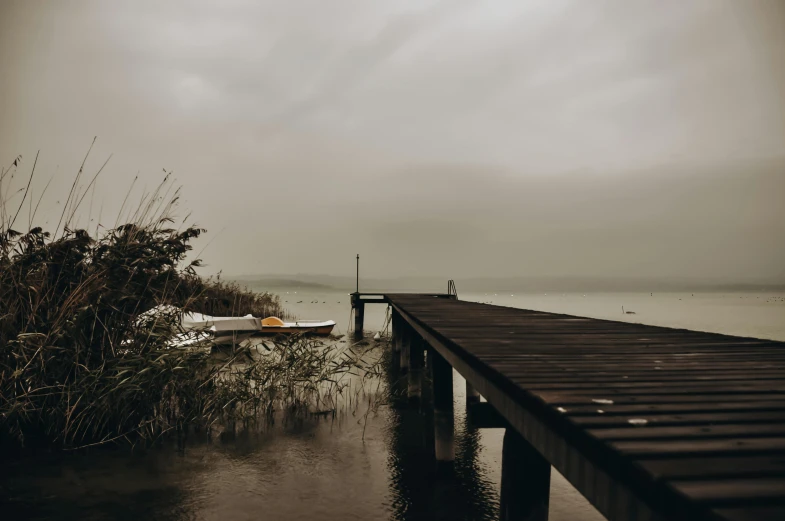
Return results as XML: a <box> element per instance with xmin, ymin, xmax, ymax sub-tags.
<box><xmin>0</xmin><ymin>0</ymin><xmax>785</xmax><ymax>281</ymax></box>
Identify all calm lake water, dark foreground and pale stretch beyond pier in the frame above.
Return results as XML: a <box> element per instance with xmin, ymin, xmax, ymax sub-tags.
<box><xmin>0</xmin><ymin>289</ymin><xmax>785</xmax><ymax>521</ymax></box>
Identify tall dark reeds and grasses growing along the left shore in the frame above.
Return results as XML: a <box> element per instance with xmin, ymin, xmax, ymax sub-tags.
<box><xmin>0</xmin><ymin>148</ymin><xmax>374</xmax><ymax>448</ymax></box>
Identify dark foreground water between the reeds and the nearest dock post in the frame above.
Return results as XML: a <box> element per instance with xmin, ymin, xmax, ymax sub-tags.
<box><xmin>0</xmin><ymin>348</ymin><xmax>499</xmax><ymax>521</ymax></box>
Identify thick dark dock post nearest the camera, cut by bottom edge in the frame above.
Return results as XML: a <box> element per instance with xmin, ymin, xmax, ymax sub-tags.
<box><xmin>500</xmin><ymin>428</ymin><xmax>551</xmax><ymax>521</ymax></box>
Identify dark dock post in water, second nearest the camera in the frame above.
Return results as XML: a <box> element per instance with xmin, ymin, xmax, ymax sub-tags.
<box><xmin>428</xmin><ymin>349</ymin><xmax>455</xmax><ymax>464</ymax></box>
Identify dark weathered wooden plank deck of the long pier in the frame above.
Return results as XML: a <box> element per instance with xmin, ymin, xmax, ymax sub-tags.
<box><xmin>384</xmin><ymin>294</ymin><xmax>785</xmax><ymax>521</ymax></box>
